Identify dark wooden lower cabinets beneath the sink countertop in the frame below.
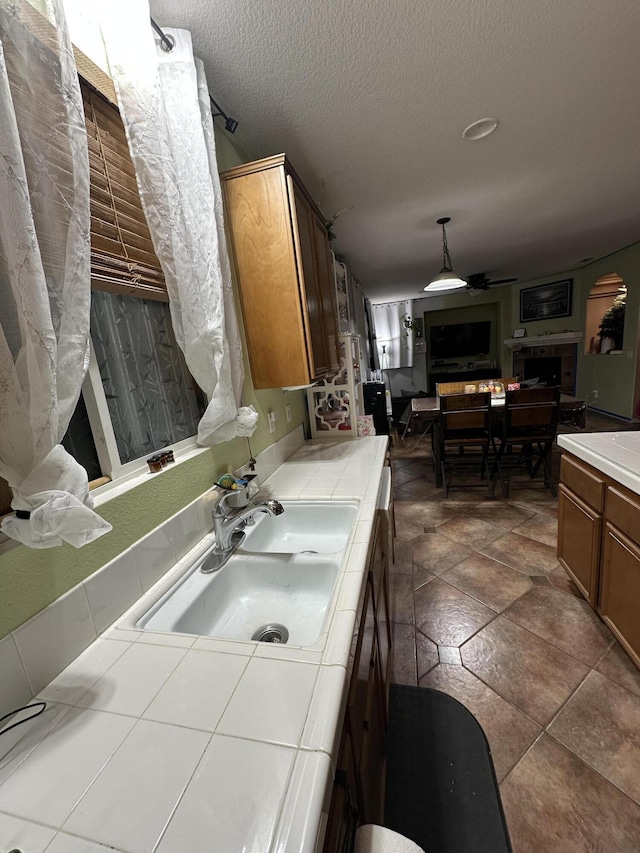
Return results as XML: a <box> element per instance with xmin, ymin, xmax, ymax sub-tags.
<box><xmin>324</xmin><ymin>524</ymin><xmax>392</xmax><ymax>853</ymax></box>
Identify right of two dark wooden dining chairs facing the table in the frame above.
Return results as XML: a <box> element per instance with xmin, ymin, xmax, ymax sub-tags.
<box><xmin>495</xmin><ymin>387</ymin><xmax>560</xmax><ymax>497</ymax></box>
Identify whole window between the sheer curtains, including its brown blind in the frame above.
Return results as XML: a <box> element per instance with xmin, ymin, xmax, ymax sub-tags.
<box><xmin>74</xmin><ymin>81</ymin><xmax>206</xmax><ymax>478</ymax></box>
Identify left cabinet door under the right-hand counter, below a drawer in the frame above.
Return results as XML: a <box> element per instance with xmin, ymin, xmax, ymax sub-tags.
<box><xmin>558</xmin><ymin>483</ymin><xmax>602</xmax><ymax>607</ymax></box>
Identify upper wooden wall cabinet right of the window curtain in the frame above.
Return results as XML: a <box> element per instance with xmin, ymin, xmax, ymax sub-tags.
<box><xmin>220</xmin><ymin>154</ymin><xmax>339</xmax><ymax>389</ymax></box>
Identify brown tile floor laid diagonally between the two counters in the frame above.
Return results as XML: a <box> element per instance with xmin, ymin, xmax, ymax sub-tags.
<box><xmin>391</xmin><ymin>418</ymin><xmax>640</xmax><ymax>853</ymax></box>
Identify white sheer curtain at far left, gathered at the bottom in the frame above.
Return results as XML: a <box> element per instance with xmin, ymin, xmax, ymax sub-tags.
<box><xmin>0</xmin><ymin>0</ymin><xmax>111</xmax><ymax>548</ymax></box>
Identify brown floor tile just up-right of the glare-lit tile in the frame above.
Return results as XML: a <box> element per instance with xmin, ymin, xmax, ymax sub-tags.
<box><xmin>442</xmin><ymin>553</ymin><xmax>531</xmax><ymax>612</ymax></box>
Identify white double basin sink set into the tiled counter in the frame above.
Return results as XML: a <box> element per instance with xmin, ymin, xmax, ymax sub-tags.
<box><xmin>136</xmin><ymin>501</ymin><xmax>358</xmax><ymax>646</ymax></box>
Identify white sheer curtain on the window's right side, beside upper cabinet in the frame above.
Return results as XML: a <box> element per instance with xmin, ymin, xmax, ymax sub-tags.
<box><xmin>101</xmin><ymin>0</ymin><xmax>258</xmax><ymax>445</ymax></box>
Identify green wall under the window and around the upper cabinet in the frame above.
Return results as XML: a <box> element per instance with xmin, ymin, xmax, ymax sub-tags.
<box><xmin>0</xmin><ymin>126</ymin><xmax>308</xmax><ymax>639</ymax></box>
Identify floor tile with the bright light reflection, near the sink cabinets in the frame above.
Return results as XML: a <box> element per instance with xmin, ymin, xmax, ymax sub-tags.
<box><xmin>415</xmin><ymin>578</ymin><xmax>495</xmax><ymax>646</ymax></box>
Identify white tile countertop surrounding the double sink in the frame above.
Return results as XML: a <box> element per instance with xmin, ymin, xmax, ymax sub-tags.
<box><xmin>0</xmin><ymin>437</ymin><xmax>388</xmax><ymax>853</ymax></box>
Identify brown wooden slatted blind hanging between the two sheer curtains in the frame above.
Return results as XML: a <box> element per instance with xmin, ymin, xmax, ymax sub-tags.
<box><xmin>81</xmin><ymin>80</ymin><xmax>169</xmax><ymax>302</ymax></box>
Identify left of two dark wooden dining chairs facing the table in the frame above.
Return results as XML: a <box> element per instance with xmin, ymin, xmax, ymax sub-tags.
<box><xmin>437</xmin><ymin>391</ymin><xmax>504</xmax><ymax>498</ymax></box>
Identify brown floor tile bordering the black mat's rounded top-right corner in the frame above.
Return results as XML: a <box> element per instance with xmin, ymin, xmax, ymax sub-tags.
<box><xmin>420</xmin><ymin>666</ymin><xmax>542</xmax><ymax>781</ymax></box>
